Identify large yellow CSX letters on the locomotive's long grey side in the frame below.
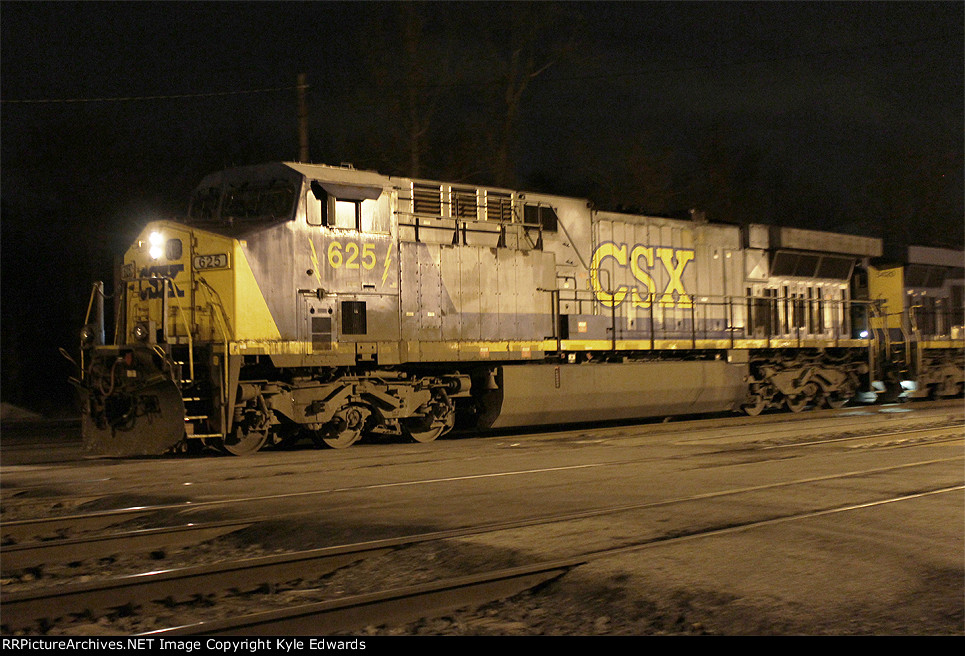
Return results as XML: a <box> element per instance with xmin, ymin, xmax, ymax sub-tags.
<box><xmin>590</xmin><ymin>242</ymin><xmax>694</xmax><ymax>308</ymax></box>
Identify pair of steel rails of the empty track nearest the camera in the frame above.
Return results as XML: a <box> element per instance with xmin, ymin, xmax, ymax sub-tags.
<box><xmin>3</xmin><ymin>459</ymin><xmax>961</xmax><ymax>634</ymax></box>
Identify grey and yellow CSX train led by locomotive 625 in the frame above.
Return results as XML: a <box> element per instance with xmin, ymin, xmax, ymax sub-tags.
<box><xmin>75</xmin><ymin>163</ymin><xmax>963</xmax><ymax>455</ymax></box>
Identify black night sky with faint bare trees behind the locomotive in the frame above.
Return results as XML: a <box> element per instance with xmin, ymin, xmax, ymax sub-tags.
<box><xmin>0</xmin><ymin>2</ymin><xmax>965</xmax><ymax>414</ymax></box>
